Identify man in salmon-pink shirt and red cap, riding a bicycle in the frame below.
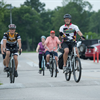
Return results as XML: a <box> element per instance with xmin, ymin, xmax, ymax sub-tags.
<box><xmin>45</xmin><ymin>30</ymin><xmax>61</xmax><ymax>72</ymax></box>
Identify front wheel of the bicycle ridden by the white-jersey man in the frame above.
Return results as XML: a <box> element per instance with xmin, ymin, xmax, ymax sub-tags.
<box><xmin>73</xmin><ymin>57</ymin><xmax>82</xmax><ymax>83</ymax></box>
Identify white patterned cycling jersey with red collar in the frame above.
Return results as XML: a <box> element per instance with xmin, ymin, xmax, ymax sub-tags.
<box><xmin>59</xmin><ymin>23</ymin><xmax>80</xmax><ymax>41</ymax></box>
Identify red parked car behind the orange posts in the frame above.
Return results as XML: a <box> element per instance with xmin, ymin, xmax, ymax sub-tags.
<box><xmin>85</xmin><ymin>43</ymin><xmax>100</xmax><ymax>60</ymax></box>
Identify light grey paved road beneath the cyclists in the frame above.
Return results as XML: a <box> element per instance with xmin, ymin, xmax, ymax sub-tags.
<box><xmin>0</xmin><ymin>53</ymin><xmax>100</xmax><ymax>100</ymax></box>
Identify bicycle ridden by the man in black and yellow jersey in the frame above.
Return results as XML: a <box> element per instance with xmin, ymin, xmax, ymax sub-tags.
<box><xmin>7</xmin><ymin>48</ymin><xmax>21</xmax><ymax>83</ymax></box>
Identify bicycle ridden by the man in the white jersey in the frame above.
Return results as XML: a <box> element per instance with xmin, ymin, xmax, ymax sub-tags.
<box><xmin>61</xmin><ymin>41</ymin><xmax>82</xmax><ymax>83</ymax></box>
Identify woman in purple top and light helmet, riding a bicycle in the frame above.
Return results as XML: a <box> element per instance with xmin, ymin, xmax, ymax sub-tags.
<box><xmin>36</xmin><ymin>36</ymin><xmax>46</xmax><ymax>74</ymax></box>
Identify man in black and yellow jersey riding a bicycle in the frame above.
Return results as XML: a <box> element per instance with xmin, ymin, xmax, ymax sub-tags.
<box><xmin>3</xmin><ymin>24</ymin><xmax>22</xmax><ymax>77</ymax></box>
